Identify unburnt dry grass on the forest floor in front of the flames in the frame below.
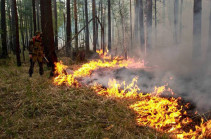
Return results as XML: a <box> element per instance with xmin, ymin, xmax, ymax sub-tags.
<box><xmin>0</xmin><ymin>58</ymin><xmax>168</xmax><ymax>139</ymax></box>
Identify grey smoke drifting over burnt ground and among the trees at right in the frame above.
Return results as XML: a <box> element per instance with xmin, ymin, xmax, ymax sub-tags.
<box><xmin>84</xmin><ymin>0</ymin><xmax>211</xmax><ymax>112</ymax></box>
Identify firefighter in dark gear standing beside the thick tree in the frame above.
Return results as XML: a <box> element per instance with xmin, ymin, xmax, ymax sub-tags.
<box><xmin>29</xmin><ymin>32</ymin><xmax>45</xmax><ymax>77</ymax></box>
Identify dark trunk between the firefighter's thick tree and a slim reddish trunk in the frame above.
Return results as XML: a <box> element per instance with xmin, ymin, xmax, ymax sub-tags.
<box><xmin>66</xmin><ymin>0</ymin><xmax>72</xmax><ymax>56</ymax></box>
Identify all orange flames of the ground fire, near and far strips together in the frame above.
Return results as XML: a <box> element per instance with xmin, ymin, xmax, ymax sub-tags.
<box><xmin>54</xmin><ymin>51</ymin><xmax>211</xmax><ymax>138</ymax></box>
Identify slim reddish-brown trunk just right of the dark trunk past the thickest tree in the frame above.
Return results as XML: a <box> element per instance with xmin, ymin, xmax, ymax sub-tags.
<box><xmin>74</xmin><ymin>0</ymin><xmax>78</xmax><ymax>53</ymax></box>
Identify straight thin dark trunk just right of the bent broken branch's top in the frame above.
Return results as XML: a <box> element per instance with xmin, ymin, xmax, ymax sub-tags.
<box><xmin>108</xmin><ymin>0</ymin><xmax>111</xmax><ymax>52</ymax></box>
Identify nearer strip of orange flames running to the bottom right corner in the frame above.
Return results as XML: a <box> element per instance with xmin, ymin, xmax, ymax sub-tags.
<box><xmin>92</xmin><ymin>77</ymin><xmax>211</xmax><ymax>139</ymax></box>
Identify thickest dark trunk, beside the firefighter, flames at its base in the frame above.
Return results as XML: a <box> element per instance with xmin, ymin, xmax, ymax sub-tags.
<box><xmin>40</xmin><ymin>0</ymin><xmax>57</xmax><ymax>75</ymax></box>
